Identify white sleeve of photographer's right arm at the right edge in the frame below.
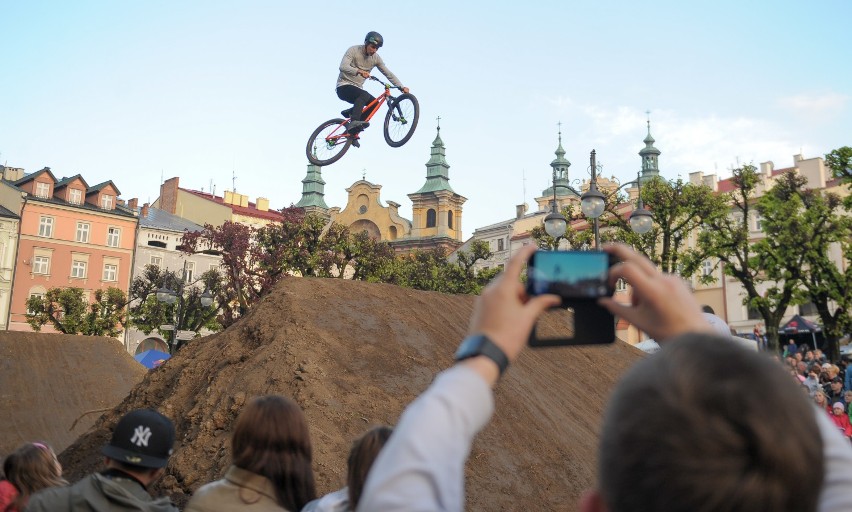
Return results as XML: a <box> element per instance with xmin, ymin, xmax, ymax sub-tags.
<box><xmin>814</xmin><ymin>408</ymin><xmax>852</xmax><ymax>512</ymax></box>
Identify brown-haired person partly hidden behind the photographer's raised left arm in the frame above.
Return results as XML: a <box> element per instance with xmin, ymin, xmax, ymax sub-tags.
<box><xmin>302</xmin><ymin>426</ymin><xmax>393</xmax><ymax>512</ymax></box>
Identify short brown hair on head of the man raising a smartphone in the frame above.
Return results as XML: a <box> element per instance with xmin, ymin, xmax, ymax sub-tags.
<box><xmin>598</xmin><ymin>334</ymin><xmax>824</xmax><ymax>512</ymax></box>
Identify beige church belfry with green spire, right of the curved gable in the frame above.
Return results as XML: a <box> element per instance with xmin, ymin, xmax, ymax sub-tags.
<box><xmin>394</xmin><ymin>122</ymin><xmax>467</xmax><ymax>254</ymax></box>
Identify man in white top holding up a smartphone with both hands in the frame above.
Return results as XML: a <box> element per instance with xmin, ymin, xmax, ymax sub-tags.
<box><xmin>359</xmin><ymin>245</ymin><xmax>852</xmax><ymax>512</ymax></box>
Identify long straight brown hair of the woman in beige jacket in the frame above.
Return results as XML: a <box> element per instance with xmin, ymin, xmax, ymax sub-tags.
<box><xmin>231</xmin><ymin>395</ymin><xmax>316</xmax><ymax>510</ymax></box>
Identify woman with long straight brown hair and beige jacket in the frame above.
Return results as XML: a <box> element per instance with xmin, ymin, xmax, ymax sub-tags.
<box><xmin>186</xmin><ymin>395</ymin><xmax>316</xmax><ymax>512</ymax></box>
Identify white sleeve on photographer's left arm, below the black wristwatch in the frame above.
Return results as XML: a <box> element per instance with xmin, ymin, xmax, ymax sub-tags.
<box><xmin>358</xmin><ymin>365</ymin><xmax>494</xmax><ymax>512</ymax></box>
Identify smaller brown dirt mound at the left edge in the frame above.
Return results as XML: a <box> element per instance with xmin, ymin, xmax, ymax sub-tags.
<box><xmin>0</xmin><ymin>331</ymin><xmax>145</xmax><ymax>458</ymax></box>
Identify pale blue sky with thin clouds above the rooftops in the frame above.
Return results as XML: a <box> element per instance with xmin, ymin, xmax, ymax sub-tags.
<box><xmin>0</xmin><ymin>0</ymin><xmax>852</xmax><ymax>238</ymax></box>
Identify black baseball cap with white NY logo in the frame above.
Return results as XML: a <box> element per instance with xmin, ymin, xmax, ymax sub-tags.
<box><xmin>101</xmin><ymin>409</ymin><xmax>175</xmax><ymax>468</ymax></box>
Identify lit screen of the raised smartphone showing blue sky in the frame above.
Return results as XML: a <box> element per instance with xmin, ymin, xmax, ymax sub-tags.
<box><xmin>527</xmin><ymin>251</ymin><xmax>612</xmax><ymax>299</ymax></box>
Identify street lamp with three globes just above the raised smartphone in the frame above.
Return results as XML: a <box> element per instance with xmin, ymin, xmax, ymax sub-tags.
<box><xmin>544</xmin><ymin>149</ymin><xmax>654</xmax><ymax>249</ymax></box>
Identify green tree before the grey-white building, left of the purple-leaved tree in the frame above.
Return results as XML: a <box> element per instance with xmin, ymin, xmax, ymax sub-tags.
<box><xmin>129</xmin><ymin>265</ymin><xmax>222</xmax><ymax>349</ymax></box>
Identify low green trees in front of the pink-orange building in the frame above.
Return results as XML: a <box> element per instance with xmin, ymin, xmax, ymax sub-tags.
<box><xmin>26</xmin><ymin>287</ymin><xmax>127</xmax><ymax>337</ymax></box>
